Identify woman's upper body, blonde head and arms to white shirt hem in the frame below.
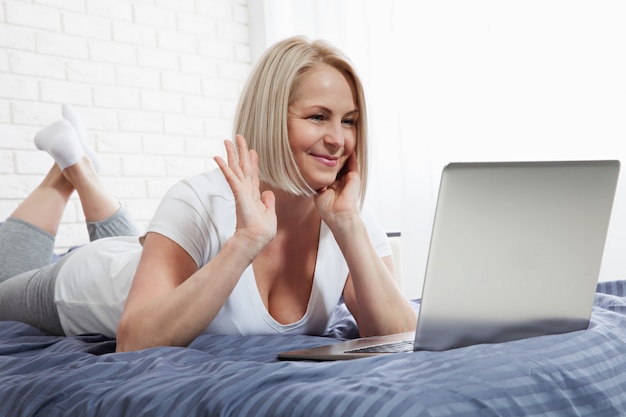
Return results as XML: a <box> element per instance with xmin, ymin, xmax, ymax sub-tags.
<box><xmin>3</xmin><ymin>37</ymin><xmax>415</xmax><ymax>351</ymax></box>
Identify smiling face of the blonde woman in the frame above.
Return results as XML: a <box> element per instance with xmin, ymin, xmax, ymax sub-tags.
<box><xmin>287</xmin><ymin>65</ymin><xmax>359</xmax><ymax>190</ymax></box>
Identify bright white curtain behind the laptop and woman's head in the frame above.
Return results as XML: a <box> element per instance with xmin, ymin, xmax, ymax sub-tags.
<box><xmin>249</xmin><ymin>0</ymin><xmax>626</xmax><ymax>296</ymax></box>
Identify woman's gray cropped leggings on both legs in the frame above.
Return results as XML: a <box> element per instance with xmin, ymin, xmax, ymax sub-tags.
<box><xmin>0</xmin><ymin>208</ymin><xmax>139</xmax><ymax>335</ymax></box>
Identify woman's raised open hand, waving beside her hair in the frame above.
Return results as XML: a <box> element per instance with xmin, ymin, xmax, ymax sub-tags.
<box><xmin>214</xmin><ymin>135</ymin><xmax>277</xmax><ymax>253</ymax></box>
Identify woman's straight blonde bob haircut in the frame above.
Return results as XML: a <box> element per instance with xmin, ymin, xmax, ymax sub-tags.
<box><xmin>234</xmin><ymin>36</ymin><xmax>368</xmax><ymax>203</ymax></box>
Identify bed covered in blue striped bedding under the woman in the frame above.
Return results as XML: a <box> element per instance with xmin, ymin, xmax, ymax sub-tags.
<box><xmin>0</xmin><ymin>281</ymin><xmax>626</xmax><ymax>417</ymax></box>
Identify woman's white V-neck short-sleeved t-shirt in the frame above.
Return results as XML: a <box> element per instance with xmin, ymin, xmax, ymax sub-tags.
<box><xmin>55</xmin><ymin>169</ymin><xmax>391</xmax><ymax>337</ymax></box>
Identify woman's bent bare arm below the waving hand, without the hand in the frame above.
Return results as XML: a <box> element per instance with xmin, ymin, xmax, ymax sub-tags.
<box><xmin>117</xmin><ymin>229</ymin><xmax>256</xmax><ymax>351</ymax></box>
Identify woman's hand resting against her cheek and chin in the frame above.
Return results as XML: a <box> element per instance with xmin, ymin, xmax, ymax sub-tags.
<box><xmin>314</xmin><ymin>154</ymin><xmax>361</xmax><ymax>230</ymax></box>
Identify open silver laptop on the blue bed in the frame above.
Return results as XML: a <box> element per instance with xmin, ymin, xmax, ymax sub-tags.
<box><xmin>278</xmin><ymin>160</ymin><xmax>620</xmax><ymax>360</ymax></box>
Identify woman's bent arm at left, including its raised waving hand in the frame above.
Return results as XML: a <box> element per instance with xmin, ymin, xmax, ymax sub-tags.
<box><xmin>117</xmin><ymin>136</ymin><xmax>276</xmax><ymax>351</ymax></box>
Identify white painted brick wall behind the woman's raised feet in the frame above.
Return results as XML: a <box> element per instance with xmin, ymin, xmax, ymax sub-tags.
<box><xmin>0</xmin><ymin>0</ymin><xmax>251</xmax><ymax>251</ymax></box>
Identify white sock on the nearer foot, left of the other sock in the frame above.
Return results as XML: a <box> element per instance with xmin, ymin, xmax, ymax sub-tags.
<box><xmin>35</xmin><ymin>120</ymin><xmax>85</xmax><ymax>171</ymax></box>
